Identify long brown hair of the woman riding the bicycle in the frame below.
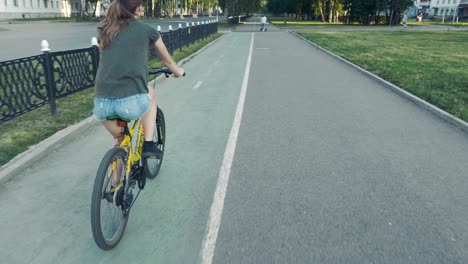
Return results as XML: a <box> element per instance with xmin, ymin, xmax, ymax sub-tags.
<box><xmin>98</xmin><ymin>0</ymin><xmax>142</xmax><ymax>48</ymax></box>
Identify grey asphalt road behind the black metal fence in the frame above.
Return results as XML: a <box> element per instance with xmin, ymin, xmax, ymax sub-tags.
<box><xmin>0</xmin><ymin>17</ymin><xmax>216</xmax><ymax>61</ymax></box>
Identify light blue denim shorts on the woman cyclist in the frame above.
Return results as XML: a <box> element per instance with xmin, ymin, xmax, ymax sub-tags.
<box><xmin>94</xmin><ymin>93</ymin><xmax>151</xmax><ymax>121</ymax></box>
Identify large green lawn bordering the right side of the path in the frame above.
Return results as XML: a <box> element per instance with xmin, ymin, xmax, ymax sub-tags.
<box><xmin>299</xmin><ymin>31</ymin><xmax>468</xmax><ymax>121</ymax></box>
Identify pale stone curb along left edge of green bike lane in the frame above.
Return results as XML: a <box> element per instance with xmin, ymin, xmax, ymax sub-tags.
<box><xmin>0</xmin><ymin>35</ymin><xmax>226</xmax><ymax>184</ymax></box>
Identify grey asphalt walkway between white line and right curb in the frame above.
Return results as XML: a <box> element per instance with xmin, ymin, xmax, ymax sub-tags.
<box><xmin>214</xmin><ymin>29</ymin><xmax>468</xmax><ymax>263</ymax></box>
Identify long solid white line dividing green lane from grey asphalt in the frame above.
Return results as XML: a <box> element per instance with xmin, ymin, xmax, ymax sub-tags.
<box><xmin>201</xmin><ymin>33</ymin><xmax>254</xmax><ymax>264</ymax></box>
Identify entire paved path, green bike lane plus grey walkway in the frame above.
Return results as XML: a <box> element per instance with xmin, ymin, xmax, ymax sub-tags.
<box><xmin>0</xmin><ymin>25</ymin><xmax>468</xmax><ymax>264</ymax></box>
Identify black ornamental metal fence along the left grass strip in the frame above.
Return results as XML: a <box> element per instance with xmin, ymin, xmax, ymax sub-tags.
<box><xmin>0</xmin><ymin>23</ymin><xmax>218</xmax><ymax>123</ymax></box>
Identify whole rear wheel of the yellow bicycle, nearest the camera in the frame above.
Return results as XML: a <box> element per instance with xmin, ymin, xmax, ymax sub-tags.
<box><xmin>91</xmin><ymin>147</ymin><xmax>130</xmax><ymax>250</ymax></box>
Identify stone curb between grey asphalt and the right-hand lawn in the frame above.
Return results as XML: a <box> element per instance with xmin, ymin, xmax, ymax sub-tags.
<box><xmin>287</xmin><ymin>30</ymin><xmax>468</xmax><ymax>133</ymax></box>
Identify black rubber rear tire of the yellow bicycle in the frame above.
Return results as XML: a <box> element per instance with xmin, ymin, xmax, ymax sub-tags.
<box><xmin>91</xmin><ymin>147</ymin><xmax>130</xmax><ymax>250</ymax></box>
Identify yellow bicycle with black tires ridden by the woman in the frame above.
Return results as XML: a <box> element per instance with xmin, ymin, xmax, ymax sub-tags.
<box><xmin>91</xmin><ymin>68</ymin><xmax>172</xmax><ymax>250</ymax></box>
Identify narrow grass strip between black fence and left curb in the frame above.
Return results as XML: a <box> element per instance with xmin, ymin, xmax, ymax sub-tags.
<box><xmin>0</xmin><ymin>33</ymin><xmax>221</xmax><ymax>165</ymax></box>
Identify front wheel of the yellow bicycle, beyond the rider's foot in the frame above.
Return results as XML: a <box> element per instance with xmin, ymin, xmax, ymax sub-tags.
<box><xmin>143</xmin><ymin>107</ymin><xmax>166</xmax><ymax>179</ymax></box>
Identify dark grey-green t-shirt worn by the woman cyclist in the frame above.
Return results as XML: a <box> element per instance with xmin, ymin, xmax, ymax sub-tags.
<box><xmin>95</xmin><ymin>19</ymin><xmax>160</xmax><ymax>99</ymax></box>
